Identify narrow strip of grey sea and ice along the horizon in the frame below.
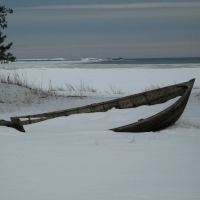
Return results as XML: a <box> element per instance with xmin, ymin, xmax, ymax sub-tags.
<box><xmin>0</xmin><ymin>57</ymin><xmax>200</xmax><ymax>70</ymax></box>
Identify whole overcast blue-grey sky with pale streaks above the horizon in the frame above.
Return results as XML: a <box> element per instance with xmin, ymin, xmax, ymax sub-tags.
<box><xmin>1</xmin><ymin>0</ymin><xmax>200</xmax><ymax>59</ymax></box>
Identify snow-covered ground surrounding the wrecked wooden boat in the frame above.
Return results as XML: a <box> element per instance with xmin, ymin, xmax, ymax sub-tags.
<box><xmin>0</xmin><ymin>68</ymin><xmax>200</xmax><ymax>200</ymax></box>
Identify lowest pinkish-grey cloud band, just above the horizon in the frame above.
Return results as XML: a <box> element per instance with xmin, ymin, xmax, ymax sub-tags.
<box><xmin>13</xmin><ymin>40</ymin><xmax>200</xmax><ymax>58</ymax></box>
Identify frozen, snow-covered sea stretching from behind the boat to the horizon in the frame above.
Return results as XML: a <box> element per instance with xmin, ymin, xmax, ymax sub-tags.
<box><xmin>0</xmin><ymin>58</ymin><xmax>200</xmax><ymax>93</ymax></box>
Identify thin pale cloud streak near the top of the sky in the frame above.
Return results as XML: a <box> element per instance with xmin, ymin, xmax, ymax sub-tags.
<box><xmin>18</xmin><ymin>2</ymin><xmax>200</xmax><ymax>10</ymax></box>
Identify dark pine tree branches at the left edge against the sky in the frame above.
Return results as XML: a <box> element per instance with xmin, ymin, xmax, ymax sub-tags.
<box><xmin>0</xmin><ymin>6</ymin><xmax>16</xmax><ymax>63</ymax></box>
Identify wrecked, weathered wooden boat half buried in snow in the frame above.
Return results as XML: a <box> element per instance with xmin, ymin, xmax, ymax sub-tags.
<box><xmin>0</xmin><ymin>79</ymin><xmax>195</xmax><ymax>132</ymax></box>
